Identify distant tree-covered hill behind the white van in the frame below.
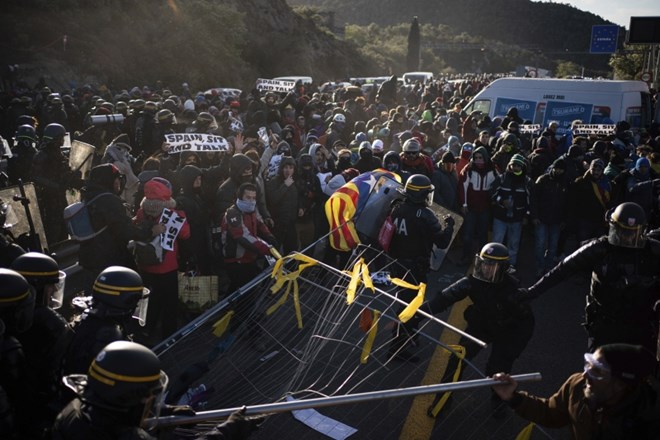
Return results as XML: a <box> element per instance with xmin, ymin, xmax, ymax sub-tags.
<box><xmin>288</xmin><ymin>0</ymin><xmax>625</xmax><ymax>76</ymax></box>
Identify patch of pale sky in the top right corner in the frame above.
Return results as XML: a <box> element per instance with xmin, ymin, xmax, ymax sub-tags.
<box><xmin>555</xmin><ymin>0</ymin><xmax>660</xmax><ymax>29</ymax></box>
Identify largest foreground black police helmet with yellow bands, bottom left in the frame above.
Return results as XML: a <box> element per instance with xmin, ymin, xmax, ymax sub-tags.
<box><xmin>83</xmin><ymin>341</ymin><xmax>168</xmax><ymax>425</ymax></box>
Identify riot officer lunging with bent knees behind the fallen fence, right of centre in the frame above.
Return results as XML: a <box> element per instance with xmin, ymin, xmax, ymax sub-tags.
<box><xmin>424</xmin><ymin>243</ymin><xmax>534</xmax><ymax>417</ymax></box>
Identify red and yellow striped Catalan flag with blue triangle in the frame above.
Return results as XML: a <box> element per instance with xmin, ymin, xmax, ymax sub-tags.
<box><xmin>325</xmin><ymin>168</ymin><xmax>401</xmax><ymax>251</ymax></box>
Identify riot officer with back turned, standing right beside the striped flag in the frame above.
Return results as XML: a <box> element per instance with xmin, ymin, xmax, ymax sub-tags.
<box><xmin>388</xmin><ymin>174</ymin><xmax>454</xmax><ymax>362</ymax></box>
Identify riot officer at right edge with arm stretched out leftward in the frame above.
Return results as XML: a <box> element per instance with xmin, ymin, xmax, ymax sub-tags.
<box><xmin>521</xmin><ymin>202</ymin><xmax>660</xmax><ymax>352</ymax></box>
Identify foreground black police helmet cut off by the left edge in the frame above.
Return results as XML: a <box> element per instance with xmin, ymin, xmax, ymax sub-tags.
<box><xmin>0</xmin><ymin>268</ymin><xmax>34</xmax><ymax>334</ymax></box>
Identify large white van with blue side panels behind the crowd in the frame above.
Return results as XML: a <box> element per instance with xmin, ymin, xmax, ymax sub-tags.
<box><xmin>465</xmin><ymin>78</ymin><xmax>653</xmax><ymax>133</ymax></box>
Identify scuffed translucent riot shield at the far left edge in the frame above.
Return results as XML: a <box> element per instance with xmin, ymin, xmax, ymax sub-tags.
<box><xmin>0</xmin><ymin>183</ymin><xmax>48</xmax><ymax>251</ymax></box>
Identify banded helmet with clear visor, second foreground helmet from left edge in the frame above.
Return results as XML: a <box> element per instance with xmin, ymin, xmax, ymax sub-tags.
<box><xmin>11</xmin><ymin>252</ymin><xmax>66</xmax><ymax>309</ymax></box>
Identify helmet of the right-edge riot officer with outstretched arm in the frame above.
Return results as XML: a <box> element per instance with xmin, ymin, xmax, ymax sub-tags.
<box><xmin>607</xmin><ymin>202</ymin><xmax>646</xmax><ymax>248</ymax></box>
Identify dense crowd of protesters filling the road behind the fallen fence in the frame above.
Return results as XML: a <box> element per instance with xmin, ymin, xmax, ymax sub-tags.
<box><xmin>0</xmin><ymin>76</ymin><xmax>660</xmax><ymax>438</ymax></box>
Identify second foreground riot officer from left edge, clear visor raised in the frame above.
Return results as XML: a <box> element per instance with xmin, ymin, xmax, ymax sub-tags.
<box><xmin>11</xmin><ymin>252</ymin><xmax>73</xmax><ymax>428</ymax></box>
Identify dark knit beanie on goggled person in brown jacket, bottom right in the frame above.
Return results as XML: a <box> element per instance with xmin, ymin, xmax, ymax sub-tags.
<box><xmin>598</xmin><ymin>344</ymin><xmax>658</xmax><ymax>384</ymax></box>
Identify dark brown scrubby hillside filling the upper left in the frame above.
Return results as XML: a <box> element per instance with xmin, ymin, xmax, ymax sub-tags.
<box><xmin>0</xmin><ymin>0</ymin><xmax>369</xmax><ymax>89</ymax></box>
